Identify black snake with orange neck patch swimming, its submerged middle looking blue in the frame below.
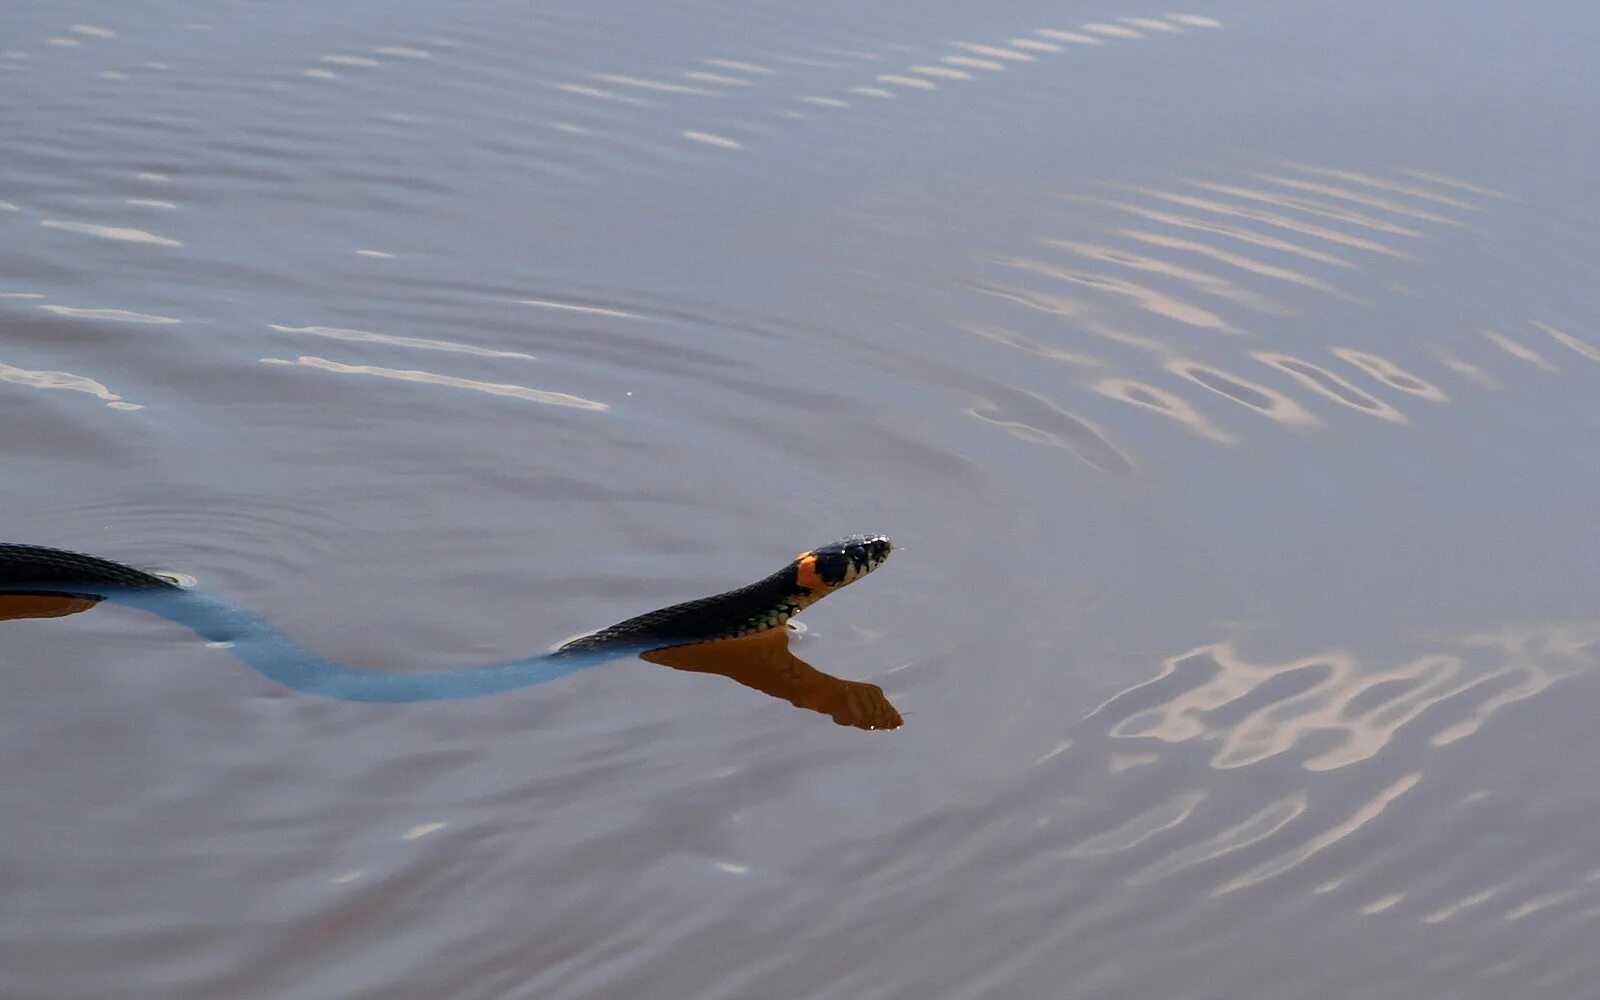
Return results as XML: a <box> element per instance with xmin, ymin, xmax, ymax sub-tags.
<box><xmin>0</xmin><ymin>534</ymin><xmax>891</xmax><ymax>704</ymax></box>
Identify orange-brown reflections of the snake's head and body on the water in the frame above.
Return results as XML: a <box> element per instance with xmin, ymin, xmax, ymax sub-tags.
<box><xmin>0</xmin><ymin>594</ymin><xmax>902</xmax><ymax>730</ymax></box>
